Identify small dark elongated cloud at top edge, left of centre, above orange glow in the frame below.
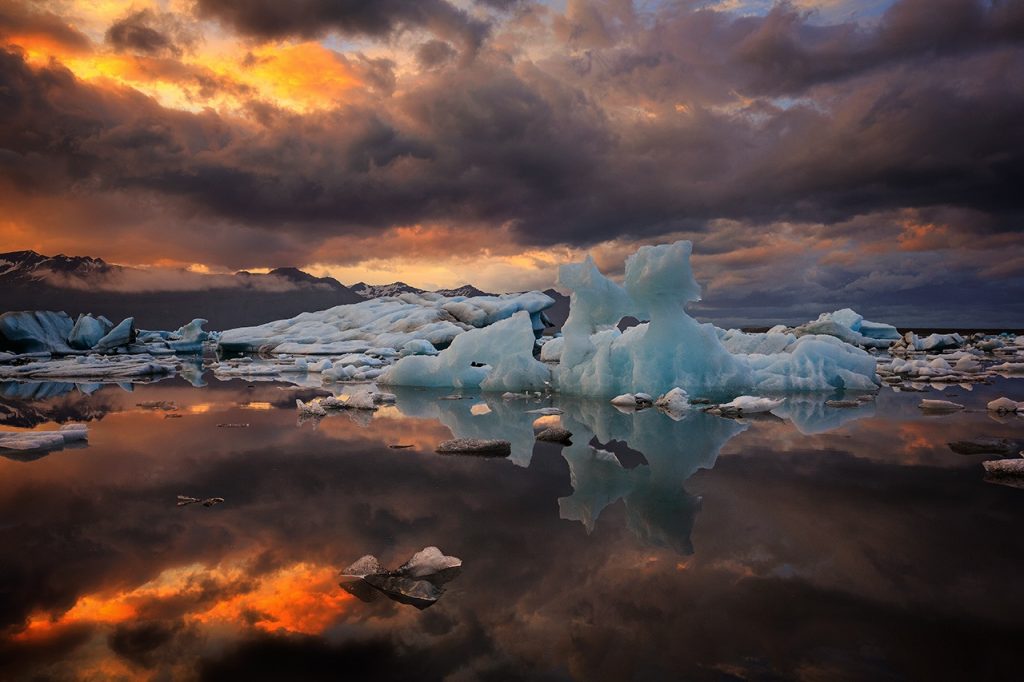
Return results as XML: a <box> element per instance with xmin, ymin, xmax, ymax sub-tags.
<box><xmin>197</xmin><ymin>0</ymin><xmax>488</xmax><ymax>50</ymax></box>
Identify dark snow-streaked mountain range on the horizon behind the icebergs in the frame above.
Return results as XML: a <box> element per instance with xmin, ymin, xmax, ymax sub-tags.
<box><xmin>0</xmin><ymin>251</ymin><xmax>567</xmax><ymax>330</ymax></box>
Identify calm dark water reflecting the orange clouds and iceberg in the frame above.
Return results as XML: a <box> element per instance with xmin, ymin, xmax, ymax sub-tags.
<box><xmin>0</xmin><ymin>380</ymin><xmax>1024</xmax><ymax>681</ymax></box>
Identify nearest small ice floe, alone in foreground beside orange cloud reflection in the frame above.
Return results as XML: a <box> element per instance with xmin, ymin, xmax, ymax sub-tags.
<box><xmin>341</xmin><ymin>547</ymin><xmax>462</xmax><ymax>609</ymax></box>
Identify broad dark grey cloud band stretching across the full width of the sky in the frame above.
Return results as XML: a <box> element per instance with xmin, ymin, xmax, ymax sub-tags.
<box><xmin>0</xmin><ymin>0</ymin><xmax>1024</xmax><ymax>243</ymax></box>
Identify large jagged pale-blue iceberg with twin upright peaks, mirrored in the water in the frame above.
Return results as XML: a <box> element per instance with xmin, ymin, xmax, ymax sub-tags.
<box><xmin>380</xmin><ymin>241</ymin><xmax>879</xmax><ymax>396</ymax></box>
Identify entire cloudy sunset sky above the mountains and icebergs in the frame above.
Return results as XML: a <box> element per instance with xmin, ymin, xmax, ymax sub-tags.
<box><xmin>0</xmin><ymin>0</ymin><xmax>1024</xmax><ymax>327</ymax></box>
